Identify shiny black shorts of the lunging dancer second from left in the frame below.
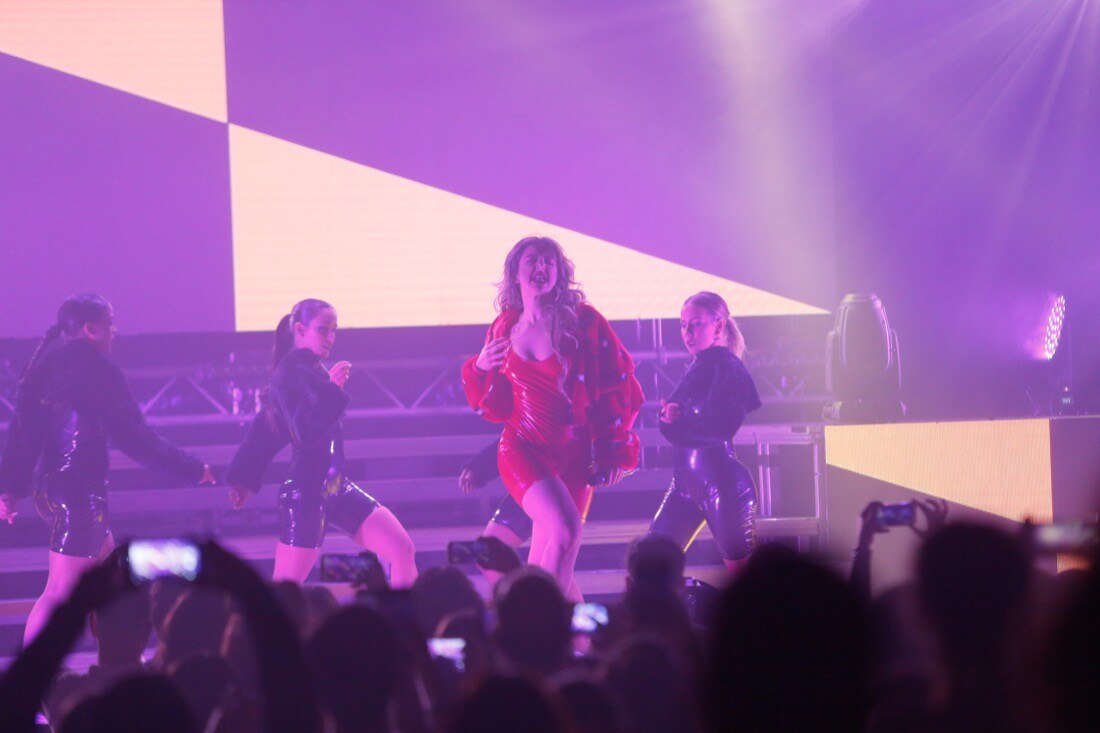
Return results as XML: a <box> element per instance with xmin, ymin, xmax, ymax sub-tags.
<box><xmin>278</xmin><ymin>479</ymin><xmax>382</xmax><ymax>547</ymax></box>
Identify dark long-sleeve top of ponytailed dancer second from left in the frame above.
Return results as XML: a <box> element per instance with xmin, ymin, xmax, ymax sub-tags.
<box><xmin>226</xmin><ymin>349</ymin><xmax>350</xmax><ymax>491</ymax></box>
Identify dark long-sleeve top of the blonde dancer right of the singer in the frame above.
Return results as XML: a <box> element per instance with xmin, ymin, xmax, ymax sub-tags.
<box><xmin>660</xmin><ymin>346</ymin><xmax>761</xmax><ymax>448</ymax></box>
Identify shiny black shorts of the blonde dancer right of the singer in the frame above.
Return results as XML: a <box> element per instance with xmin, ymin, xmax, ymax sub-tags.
<box><xmin>649</xmin><ymin>444</ymin><xmax>757</xmax><ymax>560</ymax></box>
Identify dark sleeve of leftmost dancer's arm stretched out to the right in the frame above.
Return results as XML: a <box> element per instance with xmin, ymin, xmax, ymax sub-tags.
<box><xmin>96</xmin><ymin>360</ymin><xmax>202</xmax><ymax>483</ymax></box>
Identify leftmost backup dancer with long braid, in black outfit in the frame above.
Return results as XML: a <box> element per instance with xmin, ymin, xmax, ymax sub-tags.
<box><xmin>0</xmin><ymin>293</ymin><xmax>213</xmax><ymax>644</ymax></box>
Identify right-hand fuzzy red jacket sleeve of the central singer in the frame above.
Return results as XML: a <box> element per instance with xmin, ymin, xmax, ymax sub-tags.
<box><xmin>582</xmin><ymin>306</ymin><xmax>645</xmax><ymax>471</ymax></box>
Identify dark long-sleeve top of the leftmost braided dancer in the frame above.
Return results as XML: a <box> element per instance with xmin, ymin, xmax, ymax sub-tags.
<box><xmin>0</xmin><ymin>339</ymin><xmax>202</xmax><ymax>497</ymax></box>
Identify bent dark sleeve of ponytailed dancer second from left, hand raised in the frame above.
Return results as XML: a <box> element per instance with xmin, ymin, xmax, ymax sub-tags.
<box><xmin>272</xmin><ymin>354</ymin><xmax>351</xmax><ymax>445</ymax></box>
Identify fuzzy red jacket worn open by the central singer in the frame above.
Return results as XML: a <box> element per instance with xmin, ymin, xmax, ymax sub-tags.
<box><xmin>462</xmin><ymin>303</ymin><xmax>644</xmax><ymax>471</ymax></box>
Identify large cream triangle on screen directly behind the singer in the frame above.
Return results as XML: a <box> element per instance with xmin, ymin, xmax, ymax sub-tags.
<box><xmin>229</xmin><ymin>124</ymin><xmax>826</xmax><ymax>330</ymax></box>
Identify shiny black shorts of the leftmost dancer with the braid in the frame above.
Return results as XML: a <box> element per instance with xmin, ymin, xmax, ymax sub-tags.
<box><xmin>34</xmin><ymin>477</ymin><xmax>111</xmax><ymax>557</ymax></box>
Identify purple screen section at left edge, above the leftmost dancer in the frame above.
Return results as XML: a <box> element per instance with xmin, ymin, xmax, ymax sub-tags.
<box><xmin>0</xmin><ymin>54</ymin><xmax>233</xmax><ymax>337</ymax></box>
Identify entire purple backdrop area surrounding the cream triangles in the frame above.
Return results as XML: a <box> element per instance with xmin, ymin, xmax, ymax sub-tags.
<box><xmin>0</xmin><ymin>0</ymin><xmax>1100</xmax><ymax>416</ymax></box>
